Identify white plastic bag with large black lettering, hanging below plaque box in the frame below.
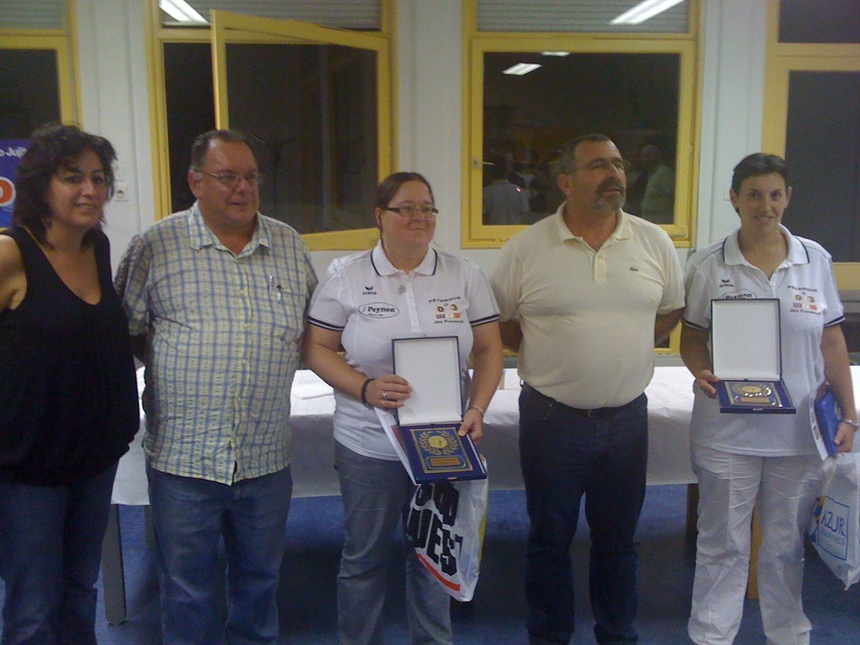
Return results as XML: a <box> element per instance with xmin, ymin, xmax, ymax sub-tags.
<box><xmin>406</xmin><ymin>464</ymin><xmax>489</xmax><ymax>602</ymax></box>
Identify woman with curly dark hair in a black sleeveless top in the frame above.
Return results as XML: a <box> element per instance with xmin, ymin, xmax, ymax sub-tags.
<box><xmin>0</xmin><ymin>125</ymin><xmax>139</xmax><ymax>645</ymax></box>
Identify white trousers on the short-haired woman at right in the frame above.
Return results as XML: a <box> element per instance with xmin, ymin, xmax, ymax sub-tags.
<box><xmin>687</xmin><ymin>444</ymin><xmax>822</xmax><ymax>645</ymax></box>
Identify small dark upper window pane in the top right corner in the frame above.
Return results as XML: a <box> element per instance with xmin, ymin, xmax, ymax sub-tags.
<box><xmin>779</xmin><ymin>0</ymin><xmax>860</xmax><ymax>43</ymax></box>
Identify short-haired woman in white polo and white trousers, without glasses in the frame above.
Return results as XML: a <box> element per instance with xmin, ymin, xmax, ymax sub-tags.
<box><xmin>681</xmin><ymin>153</ymin><xmax>857</xmax><ymax>645</ymax></box>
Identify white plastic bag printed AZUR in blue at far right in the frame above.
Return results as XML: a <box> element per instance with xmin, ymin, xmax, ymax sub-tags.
<box><xmin>809</xmin><ymin>452</ymin><xmax>860</xmax><ymax>589</ymax></box>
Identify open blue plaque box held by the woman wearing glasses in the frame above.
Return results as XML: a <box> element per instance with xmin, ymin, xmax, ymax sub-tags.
<box><xmin>380</xmin><ymin>336</ymin><xmax>487</xmax><ymax>484</ymax></box>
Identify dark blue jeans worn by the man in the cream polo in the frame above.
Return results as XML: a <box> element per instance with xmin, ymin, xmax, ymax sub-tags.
<box><xmin>520</xmin><ymin>385</ymin><xmax>648</xmax><ymax>643</ymax></box>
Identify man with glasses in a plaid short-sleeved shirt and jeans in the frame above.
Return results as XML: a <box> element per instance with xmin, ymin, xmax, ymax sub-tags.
<box><xmin>116</xmin><ymin>130</ymin><xmax>317</xmax><ymax>645</ymax></box>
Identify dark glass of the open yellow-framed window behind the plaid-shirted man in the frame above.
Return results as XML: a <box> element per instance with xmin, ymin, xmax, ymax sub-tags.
<box><xmin>227</xmin><ymin>44</ymin><xmax>378</xmax><ymax>234</ymax></box>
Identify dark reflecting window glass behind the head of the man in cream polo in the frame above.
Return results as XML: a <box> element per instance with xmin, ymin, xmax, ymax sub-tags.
<box><xmin>483</xmin><ymin>52</ymin><xmax>681</xmax><ymax>224</ymax></box>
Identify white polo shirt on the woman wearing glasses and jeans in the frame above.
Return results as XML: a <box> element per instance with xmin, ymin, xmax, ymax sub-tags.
<box><xmin>310</xmin><ymin>242</ymin><xmax>499</xmax><ymax>461</ymax></box>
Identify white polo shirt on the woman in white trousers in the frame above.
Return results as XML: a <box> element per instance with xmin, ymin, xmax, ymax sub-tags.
<box><xmin>683</xmin><ymin>226</ymin><xmax>844</xmax><ymax>456</ymax></box>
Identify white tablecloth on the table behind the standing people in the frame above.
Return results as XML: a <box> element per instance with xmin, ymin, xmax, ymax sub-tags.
<box><xmin>113</xmin><ymin>367</ymin><xmax>695</xmax><ymax>506</ymax></box>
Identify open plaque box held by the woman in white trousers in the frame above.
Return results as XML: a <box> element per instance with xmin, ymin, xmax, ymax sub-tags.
<box><xmin>711</xmin><ymin>298</ymin><xmax>797</xmax><ymax>414</ymax></box>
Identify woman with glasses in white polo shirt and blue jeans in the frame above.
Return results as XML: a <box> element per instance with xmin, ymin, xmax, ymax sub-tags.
<box><xmin>304</xmin><ymin>172</ymin><xmax>502</xmax><ymax>644</ymax></box>
